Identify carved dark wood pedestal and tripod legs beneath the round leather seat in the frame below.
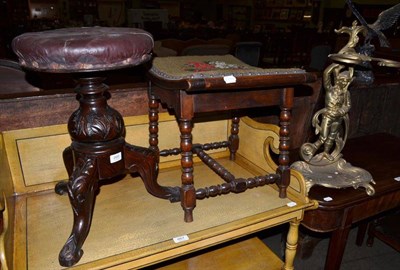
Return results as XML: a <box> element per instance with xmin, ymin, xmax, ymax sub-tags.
<box><xmin>55</xmin><ymin>77</ymin><xmax>164</xmax><ymax>266</ymax></box>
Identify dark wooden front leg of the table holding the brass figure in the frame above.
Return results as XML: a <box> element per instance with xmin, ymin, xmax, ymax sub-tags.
<box><xmin>325</xmin><ymin>226</ymin><xmax>350</xmax><ymax>270</ymax></box>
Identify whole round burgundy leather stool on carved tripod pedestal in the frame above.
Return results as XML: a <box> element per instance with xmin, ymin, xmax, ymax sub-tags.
<box><xmin>12</xmin><ymin>27</ymin><xmax>170</xmax><ymax>266</ymax></box>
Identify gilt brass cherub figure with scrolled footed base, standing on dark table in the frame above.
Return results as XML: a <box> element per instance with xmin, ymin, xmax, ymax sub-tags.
<box><xmin>291</xmin><ymin>50</ymin><xmax>375</xmax><ymax>195</ymax></box>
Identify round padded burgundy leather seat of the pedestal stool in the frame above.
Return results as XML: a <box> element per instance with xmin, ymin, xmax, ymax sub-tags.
<box><xmin>12</xmin><ymin>27</ymin><xmax>154</xmax><ymax>72</ymax></box>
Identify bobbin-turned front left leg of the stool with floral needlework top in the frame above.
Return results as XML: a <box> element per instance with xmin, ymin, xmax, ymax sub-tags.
<box><xmin>179</xmin><ymin>119</ymin><xmax>196</xmax><ymax>222</ymax></box>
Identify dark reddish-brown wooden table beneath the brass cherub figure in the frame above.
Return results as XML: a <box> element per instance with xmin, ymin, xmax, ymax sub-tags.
<box><xmin>302</xmin><ymin>134</ymin><xmax>400</xmax><ymax>270</ymax></box>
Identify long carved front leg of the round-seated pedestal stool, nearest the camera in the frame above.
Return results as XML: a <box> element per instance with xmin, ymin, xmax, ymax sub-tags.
<box><xmin>58</xmin><ymin>154</ymin><xmax>98</xmax><ymax>267</ymax></box>
